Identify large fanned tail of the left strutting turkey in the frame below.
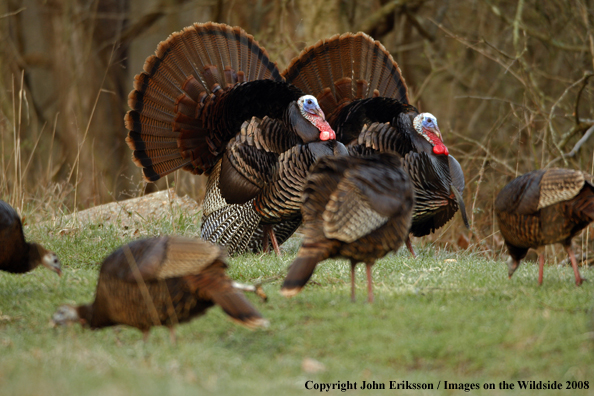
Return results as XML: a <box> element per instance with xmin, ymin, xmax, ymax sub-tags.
<box><xmin>125</xmin><ymin>22</ymin><xmax>283</xmax><ymax>181</ymax></box>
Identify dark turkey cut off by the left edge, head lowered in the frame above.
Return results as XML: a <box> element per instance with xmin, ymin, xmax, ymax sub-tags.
<box><xmin>0</xmin><ymin>200</ymin><xmax>62</xmax><ymax>275</ymax></box>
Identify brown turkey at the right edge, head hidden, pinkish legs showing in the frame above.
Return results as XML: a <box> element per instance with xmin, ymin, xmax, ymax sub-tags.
<box><xmin>495</xmin><ymin>169</ymin><xmax>594</xmax><ymax>286</ymax></box>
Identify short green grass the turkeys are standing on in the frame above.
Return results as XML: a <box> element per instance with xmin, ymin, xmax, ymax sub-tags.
<box><xmin>0</xmin><ymin>216</ymin><xmax>594</xmax><ymax>396</ymax></box>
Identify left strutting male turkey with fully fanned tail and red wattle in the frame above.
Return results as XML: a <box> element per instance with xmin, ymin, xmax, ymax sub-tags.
<box><xmin>125</xmin><ymin>22</ymin><xmax>346</xmax><ymax>253</ymax></box>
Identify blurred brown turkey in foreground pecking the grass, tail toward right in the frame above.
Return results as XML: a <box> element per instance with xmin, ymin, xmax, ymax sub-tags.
<box><xmin>52</xmin><ymin>236</ymin><xmax>268</xmax><ymax>342</ymax></box>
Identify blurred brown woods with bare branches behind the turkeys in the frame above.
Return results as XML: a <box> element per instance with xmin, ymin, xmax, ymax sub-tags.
<box><xmin>0</xmin><ymin>0</ymin><xmax>594</xmax><ymax>254</ymax></box>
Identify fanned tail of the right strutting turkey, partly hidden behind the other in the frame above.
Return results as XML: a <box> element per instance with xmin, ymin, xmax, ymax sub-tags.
<box><xmin>282</xmin><ymin>32</ymin><xmax>409</xmax><ymax>125</ymax></box>
